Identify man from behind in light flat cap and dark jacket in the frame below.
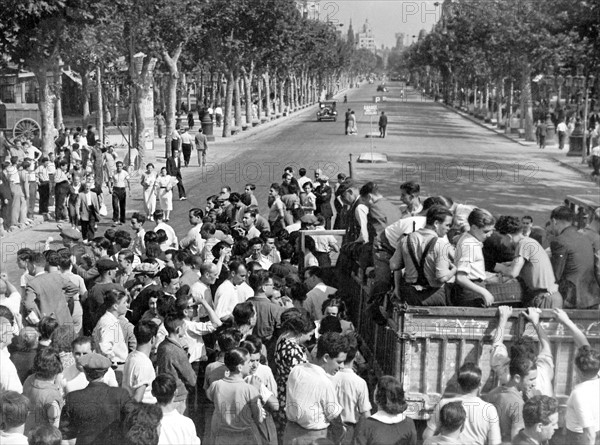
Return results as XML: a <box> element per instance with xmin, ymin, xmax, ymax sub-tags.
<box><xmin>60</xmin><ymin>353</ymin><xmax>134</xmax><ymax>445</ymax></box>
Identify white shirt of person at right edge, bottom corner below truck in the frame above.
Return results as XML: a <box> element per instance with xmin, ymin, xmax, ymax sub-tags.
<box><xmin>565</xmin><ymin>378</ymin><xmax>600</xmax><ymax>433</ymax></box>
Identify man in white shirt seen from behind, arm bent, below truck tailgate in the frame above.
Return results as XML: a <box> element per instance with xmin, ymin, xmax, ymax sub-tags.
<box><xmin>423</xmin><ymin>362</ymin><xmax>501</xmax><ymax>445</ymax></box>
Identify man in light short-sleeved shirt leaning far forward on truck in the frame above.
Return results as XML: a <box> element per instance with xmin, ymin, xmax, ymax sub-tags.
<box><xmin>494</xmin><ymin>216</ymin><xmax>563</xmax><ymax>308</ymax></box>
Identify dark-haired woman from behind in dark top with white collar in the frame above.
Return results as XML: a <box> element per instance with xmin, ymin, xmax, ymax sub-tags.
<box><xmin>354</xmin><ymin>375</ymin><xmax>417</xmax><ymax>445</ymax></box>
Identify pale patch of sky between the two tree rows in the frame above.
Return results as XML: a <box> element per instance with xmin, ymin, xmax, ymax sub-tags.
<box><xmin>310</xmin><ymin>0</ymin><xmax>442</xmax><ymax>48</ymax></box>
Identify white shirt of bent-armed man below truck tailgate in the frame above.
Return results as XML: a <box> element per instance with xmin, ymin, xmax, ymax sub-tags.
<box><xmin>427</xmin><ymin>395</ymin><xmax>502</xmax><ymax>445</ymax></box>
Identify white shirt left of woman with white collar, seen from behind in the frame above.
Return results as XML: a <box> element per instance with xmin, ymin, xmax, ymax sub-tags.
<box><xmin>332</xmin><ymin>368</ymin><xmax>372</xmax><ymax>424</ymax></box>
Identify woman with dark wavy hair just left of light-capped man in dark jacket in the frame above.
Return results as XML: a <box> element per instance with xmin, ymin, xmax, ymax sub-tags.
<box><xmin>23</xmin><ymin>348</ymin><xmax>64</xmax><ymax>434</ymax></box>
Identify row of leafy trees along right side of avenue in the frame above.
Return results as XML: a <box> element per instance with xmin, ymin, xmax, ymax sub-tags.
<box><xmin>397</xmin><ymin>0</ymin><xmax>600</xmax><ymax>140</ymax></box>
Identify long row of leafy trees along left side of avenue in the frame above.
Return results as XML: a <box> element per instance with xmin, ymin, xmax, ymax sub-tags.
<box><xmin>0</xmin><ymin>0</ymin><xmax>378</xmax><ymax>163</ymax></box>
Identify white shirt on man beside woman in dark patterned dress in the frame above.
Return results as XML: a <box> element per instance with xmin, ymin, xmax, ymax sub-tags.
<box><xmin>285</xmin><ymin>363</ymin><xmax>342</xmax><ymax>430</ymax></box>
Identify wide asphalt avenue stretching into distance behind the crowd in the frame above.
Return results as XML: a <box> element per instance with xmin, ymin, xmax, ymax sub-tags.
<box><xmin>2</xmin><ymin>82</ymin><xmax>597</xmax><ymax>282</ymax></box>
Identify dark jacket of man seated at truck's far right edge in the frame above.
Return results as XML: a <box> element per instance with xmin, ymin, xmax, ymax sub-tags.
<box><xmin>550</xmin><ymin>226</ymin><xmax>600</xmax><ymax>309</ymax></box>
